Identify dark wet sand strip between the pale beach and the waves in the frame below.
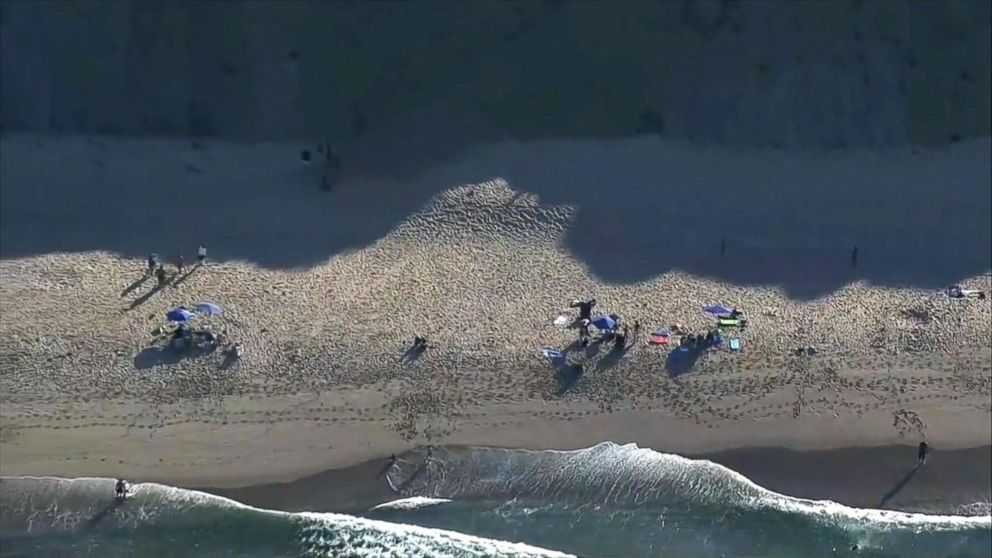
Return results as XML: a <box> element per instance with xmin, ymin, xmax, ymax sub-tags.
<box><xmin>203</xmin><ymin>445</ymin><xmax>992</xmax><ymax>515</ymax></box>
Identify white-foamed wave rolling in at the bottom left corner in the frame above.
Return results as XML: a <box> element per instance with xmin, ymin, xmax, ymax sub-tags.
<box><xmin>0</xmin><ymin>477</ymin><xmax>566</xmax><ymax>558</ymax></box>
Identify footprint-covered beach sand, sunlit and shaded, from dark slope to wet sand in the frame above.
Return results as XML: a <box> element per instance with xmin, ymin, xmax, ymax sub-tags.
<box><xmin>0</xmin><ymin>136</ymin><xmax>992</xmax><ymax>486</ymax></box>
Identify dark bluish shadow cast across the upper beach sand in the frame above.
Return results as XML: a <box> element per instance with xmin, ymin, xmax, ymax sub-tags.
<box><xmin>0</xmin><ymin>132</ymin><xmax>992</xmax><ymax>304</ymax></box>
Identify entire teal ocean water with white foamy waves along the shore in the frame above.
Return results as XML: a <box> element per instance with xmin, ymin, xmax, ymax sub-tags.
<box><xmin>0</xmin><ymin>443</ymin><xmax>992</xmax><ymax>558</ymax></box>
